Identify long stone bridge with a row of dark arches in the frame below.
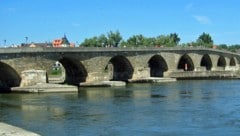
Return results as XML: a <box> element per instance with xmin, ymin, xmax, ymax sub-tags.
<box><xmin>0</xmin><ymin>47</ymin><xmax>240</xmax><ymax>91</ymax></box>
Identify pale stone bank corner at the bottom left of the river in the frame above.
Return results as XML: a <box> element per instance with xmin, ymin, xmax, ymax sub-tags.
<box><xmin>0</xmin><ymin>122</ymin><xmax>40</xmax><ymax>136</ymax></box>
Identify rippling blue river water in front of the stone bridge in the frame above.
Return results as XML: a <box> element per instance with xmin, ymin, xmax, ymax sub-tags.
<box><xmin>0</xmin><ymin>80</ymin><xmax>240</xmax><ymax>136</ymax></box>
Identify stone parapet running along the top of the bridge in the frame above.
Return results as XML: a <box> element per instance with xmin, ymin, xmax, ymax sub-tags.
<box><xmin>0</xmin><ymin>46</ymin><xmax>239</xmax><ymax>56</ymax></box>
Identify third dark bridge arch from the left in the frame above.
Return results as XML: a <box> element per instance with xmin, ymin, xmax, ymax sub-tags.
<box><xmin>109</xmin><ymin>55</ymin><xmax>134</xmax><ymax>81</ymax></box>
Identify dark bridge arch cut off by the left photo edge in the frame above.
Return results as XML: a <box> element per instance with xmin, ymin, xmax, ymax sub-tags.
<box><xmin>0</xmin><ymin>62</ymin><xmax>21</xmax><ymax>92</ymax></box>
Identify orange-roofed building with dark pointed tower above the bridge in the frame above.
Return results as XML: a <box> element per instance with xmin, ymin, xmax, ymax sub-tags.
<box><xmin>52</xmin><ymin>35</ymin><xmax>75</xmax><ymax>48</ymax></box>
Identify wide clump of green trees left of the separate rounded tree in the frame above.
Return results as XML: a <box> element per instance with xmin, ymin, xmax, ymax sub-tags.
<box><xmin>80</xmin><ymin>31</ymin><xmax>180</xmax><ymax>47</ymax></box>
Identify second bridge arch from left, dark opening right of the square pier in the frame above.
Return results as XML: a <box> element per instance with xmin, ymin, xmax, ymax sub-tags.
<box><xmin>59</xmin><ymin>58</ymin><xmax>88</xmax><ymax>86</ymax></box>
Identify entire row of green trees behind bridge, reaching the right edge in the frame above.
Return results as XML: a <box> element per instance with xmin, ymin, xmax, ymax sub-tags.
<box><xmin>80</xmin><ymin>31</ymin><xmax>240</xmax><ymax>52</ymax></box>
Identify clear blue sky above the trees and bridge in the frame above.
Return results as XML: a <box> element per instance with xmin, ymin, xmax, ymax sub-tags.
<box><xmin>0</xmin><ymin>0</ymin><xmax>240</xmax><ymax>46</ymax></box>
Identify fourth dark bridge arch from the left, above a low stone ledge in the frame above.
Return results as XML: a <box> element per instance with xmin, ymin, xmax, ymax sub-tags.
<box><xmin>148</xmin><ymin>55</ymin><xmax>168</xmax><ymax>77</ymax></box>
